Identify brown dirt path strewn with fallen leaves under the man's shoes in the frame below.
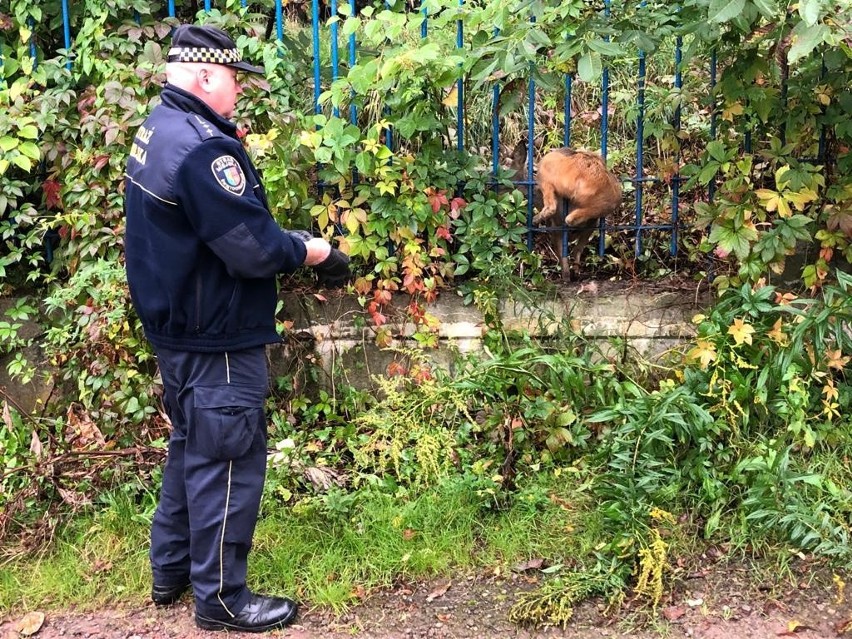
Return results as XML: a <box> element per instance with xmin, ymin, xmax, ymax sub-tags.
<box><xmin>0</xmin><ymin>566</ymin><xmax>852</xmax><ymax>639</ymax></box>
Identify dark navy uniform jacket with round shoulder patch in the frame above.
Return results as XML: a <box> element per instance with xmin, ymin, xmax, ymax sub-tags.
<box><xmin>125</xmin><ymin>84</ymin><xmax>306</xmax><ymax>352</ymax></box>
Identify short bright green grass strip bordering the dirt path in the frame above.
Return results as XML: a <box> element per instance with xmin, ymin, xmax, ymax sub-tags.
<box><xmin>0</xmin><ymin>474</ymin><xmax>603</xmax><ymax>614</ymax></box>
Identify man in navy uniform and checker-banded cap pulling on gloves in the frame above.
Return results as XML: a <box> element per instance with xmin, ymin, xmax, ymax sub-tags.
<box><xmin>125</xmin><ymin>25</ymin><xmax>349</xmax><ymax>632</ymax></box>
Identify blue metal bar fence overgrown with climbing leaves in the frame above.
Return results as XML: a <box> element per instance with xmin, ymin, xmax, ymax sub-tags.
<box><xmin>21</xmin><ymin>0</ymin><xmax>824</xmax><ymax>266</ymax></box>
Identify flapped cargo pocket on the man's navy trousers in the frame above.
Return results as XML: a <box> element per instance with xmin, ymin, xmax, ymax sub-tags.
<box><xmin>191</xmin><ymin>384</ymin><xmax>266</xmax><ymax>460</ymax></box>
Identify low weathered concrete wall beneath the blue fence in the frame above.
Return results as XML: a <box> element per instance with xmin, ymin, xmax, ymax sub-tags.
<box><xmin>0</xmin><ymin>281</ymin><xmax>710</xmax><ymax>415</ymax></box>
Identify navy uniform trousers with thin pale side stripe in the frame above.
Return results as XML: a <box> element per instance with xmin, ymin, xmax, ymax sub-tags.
<box><xmin>151</xmin><ymin>346</ymin><xmax>268</xmax><ymax>619</ymax></box>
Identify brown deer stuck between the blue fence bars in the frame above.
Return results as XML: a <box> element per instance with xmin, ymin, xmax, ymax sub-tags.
<box><xmin>509</xmin><ymin>139</ymin><xmax>621</xmax><ymax>279</ymax></box>
